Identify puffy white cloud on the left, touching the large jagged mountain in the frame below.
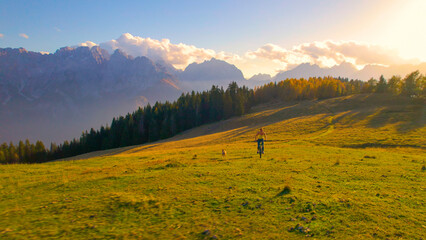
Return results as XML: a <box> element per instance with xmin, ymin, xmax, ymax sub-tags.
<box><xmin>99</xmin><ymin>33</ymin><xmax>239</xmax><ymax>69</ymax></box>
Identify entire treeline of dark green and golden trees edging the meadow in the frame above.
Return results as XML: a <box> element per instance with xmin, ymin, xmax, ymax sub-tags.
<box><xmin>0</xmin><ymin>71</ymin><xmax>426</xmax><ymax>163</ymax></box>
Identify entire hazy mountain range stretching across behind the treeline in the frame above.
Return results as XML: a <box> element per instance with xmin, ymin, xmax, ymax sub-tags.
<box><xmin>0</xmin><ymin>46</ymin><xmax>426</xmax><ymax>143</ymax></box>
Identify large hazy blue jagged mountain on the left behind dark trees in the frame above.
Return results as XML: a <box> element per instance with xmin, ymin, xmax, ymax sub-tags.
<box><xmin>0</xmin><ymin>47</ymin><xmax>182</xmax><ymax>142</ymax></box>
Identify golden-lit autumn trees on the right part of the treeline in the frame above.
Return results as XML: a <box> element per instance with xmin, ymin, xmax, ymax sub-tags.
<box><xmin>254</xmin><ymin>71</ymin><xmax>426</xmax><ymax>103</ymax></box>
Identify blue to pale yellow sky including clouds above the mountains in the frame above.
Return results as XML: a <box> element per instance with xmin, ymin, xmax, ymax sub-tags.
<box><xmin>0</xmin><ymin>0</ymin><xmax>426</xmax><ymax>77</ymax></box>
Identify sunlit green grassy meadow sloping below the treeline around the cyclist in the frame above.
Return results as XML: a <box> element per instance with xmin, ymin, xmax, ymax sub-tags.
<box><xmin>0</xmin><ymin>95</ymin><xmax>426</xmax><ymax>239</ymax></box>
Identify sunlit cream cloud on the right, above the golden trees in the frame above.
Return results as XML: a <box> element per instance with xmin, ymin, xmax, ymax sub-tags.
<box><xmin>246</xmin><ymin>40</ymin><xmax>405</xmax><ymax>68</ymax></box>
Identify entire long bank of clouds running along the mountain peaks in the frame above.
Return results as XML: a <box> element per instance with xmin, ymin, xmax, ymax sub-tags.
<box><xmin>78</xmin><ymin>33</ymin><xmax>408</xmax><ymax>77</ymax></box>
